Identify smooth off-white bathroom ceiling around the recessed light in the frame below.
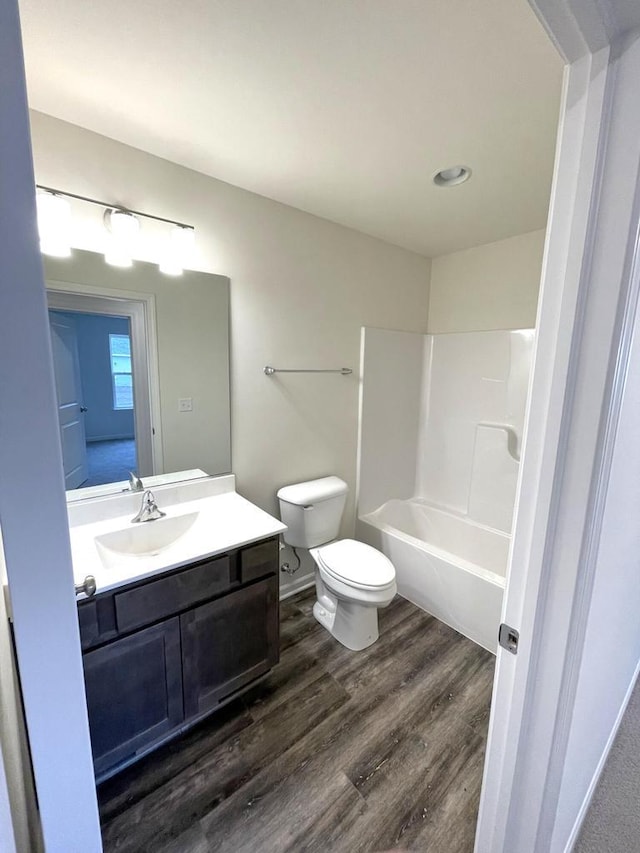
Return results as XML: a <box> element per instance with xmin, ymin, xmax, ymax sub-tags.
<box><xmin>20</xmin><ymin>0</ymin><xmax>562</xmax><ymax>256</ymax></box>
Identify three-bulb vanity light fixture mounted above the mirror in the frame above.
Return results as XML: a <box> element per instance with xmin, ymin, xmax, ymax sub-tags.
<box><xmin>36</xmin><ymin>184</ymin><xmax>195</xmax><ymax>275</ymax></box>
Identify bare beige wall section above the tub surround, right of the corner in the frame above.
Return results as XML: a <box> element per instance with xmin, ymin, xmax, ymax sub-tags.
<box><xmin>429</xmin><ymin>229</ymin><xmax>545</xmax><ymax>334</ymax></box>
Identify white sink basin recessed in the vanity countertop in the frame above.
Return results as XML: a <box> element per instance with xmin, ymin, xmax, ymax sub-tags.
<box><xmin>94</xmin><ymin>512</ymin><xmax>199</xmax><ymax>569</ymax></box>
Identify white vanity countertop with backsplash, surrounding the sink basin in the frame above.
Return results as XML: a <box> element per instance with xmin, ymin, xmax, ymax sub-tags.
<box><xmin>67</xmin><ymin>475</ymin><xmax>286</xmax><ymax>599</ymax></box>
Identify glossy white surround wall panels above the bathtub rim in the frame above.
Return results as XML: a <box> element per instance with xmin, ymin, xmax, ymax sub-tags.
<box><xmin>358</xmin><ymin>329</ymin><xmax>534</xmax><ymax>533</ymax></box>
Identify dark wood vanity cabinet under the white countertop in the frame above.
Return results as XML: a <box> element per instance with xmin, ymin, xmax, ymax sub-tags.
<box><xmin>78</xmin><ymin>538</ymin><xmax>279</xmax><ymax>779</ymax></box>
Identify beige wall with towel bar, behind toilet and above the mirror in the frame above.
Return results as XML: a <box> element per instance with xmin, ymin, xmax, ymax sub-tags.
<box><xmin>31</xmin><ymin>113</ymin><xmax>430</xmax><ymax>592</ymax></box>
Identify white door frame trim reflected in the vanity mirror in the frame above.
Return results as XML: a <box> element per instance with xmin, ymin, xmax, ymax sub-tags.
<box><xmin>46</xmin><ymin>280</ymin><xmax>164</xmax><ymax>480</ymax></box>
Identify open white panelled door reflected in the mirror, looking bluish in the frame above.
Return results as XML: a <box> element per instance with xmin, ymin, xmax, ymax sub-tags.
<box><xmin>49</xmin><ymin>311</ymin><xmax>88</xmax><ymax>489</ymax></box>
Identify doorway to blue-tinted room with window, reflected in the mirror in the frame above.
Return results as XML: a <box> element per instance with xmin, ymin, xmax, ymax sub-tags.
<box><xmin>47</xmin><ymin>285</ymin><xmax>161</xmax><ymax>490</ymax></box>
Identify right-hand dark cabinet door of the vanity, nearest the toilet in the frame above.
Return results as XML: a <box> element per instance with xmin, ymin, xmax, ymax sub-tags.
<box><xmin>180</xmin><ymin>578</ymin><xmax>278</xmax><ymax>717</ymax></box>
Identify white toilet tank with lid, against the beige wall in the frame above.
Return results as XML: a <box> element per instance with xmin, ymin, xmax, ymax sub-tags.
<box><xmin>278</xmin><ymin>477</ymin><xmax>349</xmax><ymax>548</ymax></box>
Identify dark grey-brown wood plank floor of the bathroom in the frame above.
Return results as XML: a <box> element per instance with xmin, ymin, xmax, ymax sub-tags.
<box><xmin>98</xmin><ymin>590</ymin><xmax>495</xmax><ymax>853</ymax></box>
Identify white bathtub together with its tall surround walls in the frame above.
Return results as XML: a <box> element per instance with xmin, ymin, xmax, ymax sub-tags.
<box><xmin>356</xmin><ymin>329</ymin><xmax>534</xmax><ymax>652</ymax></box>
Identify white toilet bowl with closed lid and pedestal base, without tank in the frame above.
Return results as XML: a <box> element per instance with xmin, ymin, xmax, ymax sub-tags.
<box><xmin>309</xmin><ymin>539</ymin><xmax>396</xmax><ymax>652</ymax></box>
